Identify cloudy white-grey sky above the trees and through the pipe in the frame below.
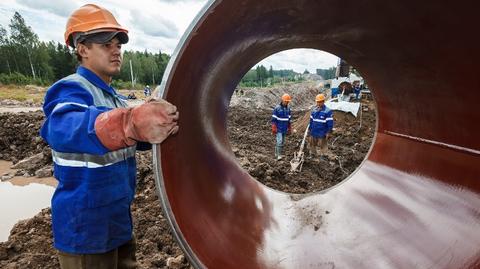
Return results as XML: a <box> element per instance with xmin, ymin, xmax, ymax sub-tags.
<box><xmin>0</xmin><ymin>0</ymin><xmax>337</xmax><ymax>73</ymax></box>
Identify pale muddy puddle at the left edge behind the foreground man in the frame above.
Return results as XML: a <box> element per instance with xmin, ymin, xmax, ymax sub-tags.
<box><xmin>0</xmin><ymin>161</ymin><xmax>57</xmax><ymax>242</ymax></box>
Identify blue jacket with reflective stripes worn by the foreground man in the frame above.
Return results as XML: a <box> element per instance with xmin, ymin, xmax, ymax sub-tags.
<box><xmin>41</xmin><ymin>67</ymin><xmax>136</xmax><ymax>254</ymax></box>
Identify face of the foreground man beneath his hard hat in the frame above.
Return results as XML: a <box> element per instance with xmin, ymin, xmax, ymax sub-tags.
<box><xmin>78</xmin><ymin>38</ymin><xmax>122</xmax><ymax>82</ymax></box>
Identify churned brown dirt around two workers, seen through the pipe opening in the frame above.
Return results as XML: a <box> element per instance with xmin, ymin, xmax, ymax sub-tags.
<box><xmin>227</xmin><ymin>100</ymin><xmax>376</xmax><ymax>193</ymax></box>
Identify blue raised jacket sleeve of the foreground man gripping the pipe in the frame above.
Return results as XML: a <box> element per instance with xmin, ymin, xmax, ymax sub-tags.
<box><xmin>40</xmin><ymin>81</ymin><xmax>111</xmax><ymax>155</ymax></box>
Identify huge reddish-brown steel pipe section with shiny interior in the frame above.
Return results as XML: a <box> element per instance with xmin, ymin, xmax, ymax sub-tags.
<box><xmin>154</xmin><ymin>0</ymin><xmax>480</xmax><ymax>269</ymax></box>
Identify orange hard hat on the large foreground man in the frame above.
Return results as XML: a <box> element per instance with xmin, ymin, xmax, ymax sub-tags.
<box><xmin>65</xmin><ymin>4</ymin><xmax>128</xmax><ymax>47</ymax></box>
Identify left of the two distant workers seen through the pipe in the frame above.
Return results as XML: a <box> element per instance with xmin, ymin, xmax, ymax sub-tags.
<box><xmin>272</xmin><ymin>93</ymin><xmax>292</xmax><ymax>160</ymax></box>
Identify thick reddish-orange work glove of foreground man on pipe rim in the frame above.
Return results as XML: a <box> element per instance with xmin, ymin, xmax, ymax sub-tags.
<box><xmin>95</xmin><ymin>99</ymin><xmax>179</xmax><ymax>150</ymax></box>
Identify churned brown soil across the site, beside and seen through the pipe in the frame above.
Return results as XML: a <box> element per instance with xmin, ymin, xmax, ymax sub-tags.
<box><xmin>0</xmin><ymin>83</ymin><xmax>376</xmax><ymax>269</ymax></box>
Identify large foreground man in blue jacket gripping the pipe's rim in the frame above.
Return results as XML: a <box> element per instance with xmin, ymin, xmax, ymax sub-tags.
<box><xmin>41</xmin><ymin>4</ymin><xmax>178</xmax><ymax>269</ymax></box>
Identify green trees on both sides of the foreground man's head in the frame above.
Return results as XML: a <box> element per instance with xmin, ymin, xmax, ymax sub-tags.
<box><xmin>0</xmin><ymin>12</ymin><xmax>170</xmax><ymax>88</ymax></box>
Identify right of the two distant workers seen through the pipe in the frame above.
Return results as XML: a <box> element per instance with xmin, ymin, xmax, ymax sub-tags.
<box><xmin>308</xmin><ymin>94</ymin><xmax>333</xmax><ymax>157</ymax></box>
